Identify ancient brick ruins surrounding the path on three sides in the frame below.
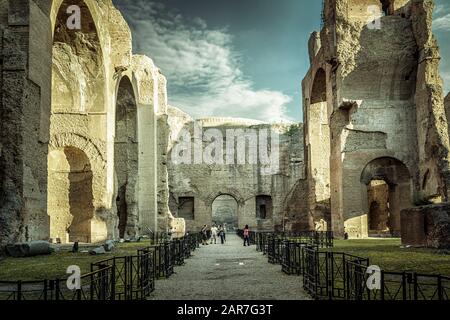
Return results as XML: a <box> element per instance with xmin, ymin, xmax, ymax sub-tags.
<box><xmin>0</xmin><ymin>0</ymin><xmax>450</xmax><ymax>247</ymax></box>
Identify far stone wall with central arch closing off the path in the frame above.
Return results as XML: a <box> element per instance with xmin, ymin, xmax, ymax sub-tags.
<box><xmin>168</xmin><ymin>107</ymin><xmax>306</xmax><ymax>230</ymax></box>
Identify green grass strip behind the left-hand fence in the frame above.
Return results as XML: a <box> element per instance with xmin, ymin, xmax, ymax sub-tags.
<box><xmin>0</xmin><ymin>241</ymin><xmax>149</xmax><ymax>281</ymax></box>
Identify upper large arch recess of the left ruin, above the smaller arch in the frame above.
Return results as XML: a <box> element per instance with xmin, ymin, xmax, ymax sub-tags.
<box><xmin>52</xmin><ymin>0</ymin><xmax>107</xmax><ymax>113</ymax></box>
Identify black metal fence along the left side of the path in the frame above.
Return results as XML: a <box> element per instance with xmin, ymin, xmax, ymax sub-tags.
<box><xmin>0</xmin><ymin>233</ymin><xmax>200</xmax><ymax>300</ymax></box>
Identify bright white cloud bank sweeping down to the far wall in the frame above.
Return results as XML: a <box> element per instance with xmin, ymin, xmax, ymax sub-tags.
<box><xmin>115</xmin><ymin>0</ymin><xmax>292</xmax><ymax>122</ymax></box>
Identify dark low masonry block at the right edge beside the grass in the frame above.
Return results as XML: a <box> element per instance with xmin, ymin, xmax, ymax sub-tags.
<box><xmin>401</xmin><ymin>203</ymin><xmax>450</xmax><ymax>249</ymax></box>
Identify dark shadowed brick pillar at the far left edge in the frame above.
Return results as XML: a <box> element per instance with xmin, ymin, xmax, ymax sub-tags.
<box><xmin>0</xmin><ymin>0</ymin><xmax>52</xmax><ymax>248</ymax></box>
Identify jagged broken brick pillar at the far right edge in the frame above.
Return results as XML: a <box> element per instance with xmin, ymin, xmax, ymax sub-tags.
<box><xmin>411</xmin><ymin>0</ymin><xmax>450</xmax><ymax>202</ymax></box>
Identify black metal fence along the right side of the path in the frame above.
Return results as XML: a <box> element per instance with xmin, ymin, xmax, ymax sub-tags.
<box><xmin>257</xmin><ymin>235</ymin><xmax>450</xmax><ymax>300</ymax></box>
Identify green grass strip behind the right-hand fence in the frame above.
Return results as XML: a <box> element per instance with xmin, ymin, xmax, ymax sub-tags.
<box><xmin>333</xmin><ymin>239</ymin><xmax>450</xmax><ymax>276</ymax></box>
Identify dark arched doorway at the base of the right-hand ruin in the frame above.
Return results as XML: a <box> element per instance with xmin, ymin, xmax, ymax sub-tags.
<box><xmin>361</xmin><ymin>157</ymin><xmax>412</xmax><ymax>236</ymax></box>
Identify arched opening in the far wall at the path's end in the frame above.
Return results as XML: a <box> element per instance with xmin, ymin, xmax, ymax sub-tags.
<box><xmin>212</xmin><ymin>194</ymin><xmax>239</xmax><ymax>229</ymax></box>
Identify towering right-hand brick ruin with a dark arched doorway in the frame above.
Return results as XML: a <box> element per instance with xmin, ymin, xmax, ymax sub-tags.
<box><xmin>303</xmin><ymin>0</ymin><xmax>449</xmax><ymax>237</ymax></box>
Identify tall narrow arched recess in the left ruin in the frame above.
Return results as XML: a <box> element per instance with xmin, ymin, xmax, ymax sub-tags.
<box><xmin>114</xmin><ymin>77</ymin><xmax>139</xmax><ymax>238</ymax></box>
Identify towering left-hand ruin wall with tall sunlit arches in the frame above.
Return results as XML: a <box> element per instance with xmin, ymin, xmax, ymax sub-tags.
<box><xmin>0</xmin><ymin>0</ymin><xmax>168</xmax><ymax>247</ymax></box>
